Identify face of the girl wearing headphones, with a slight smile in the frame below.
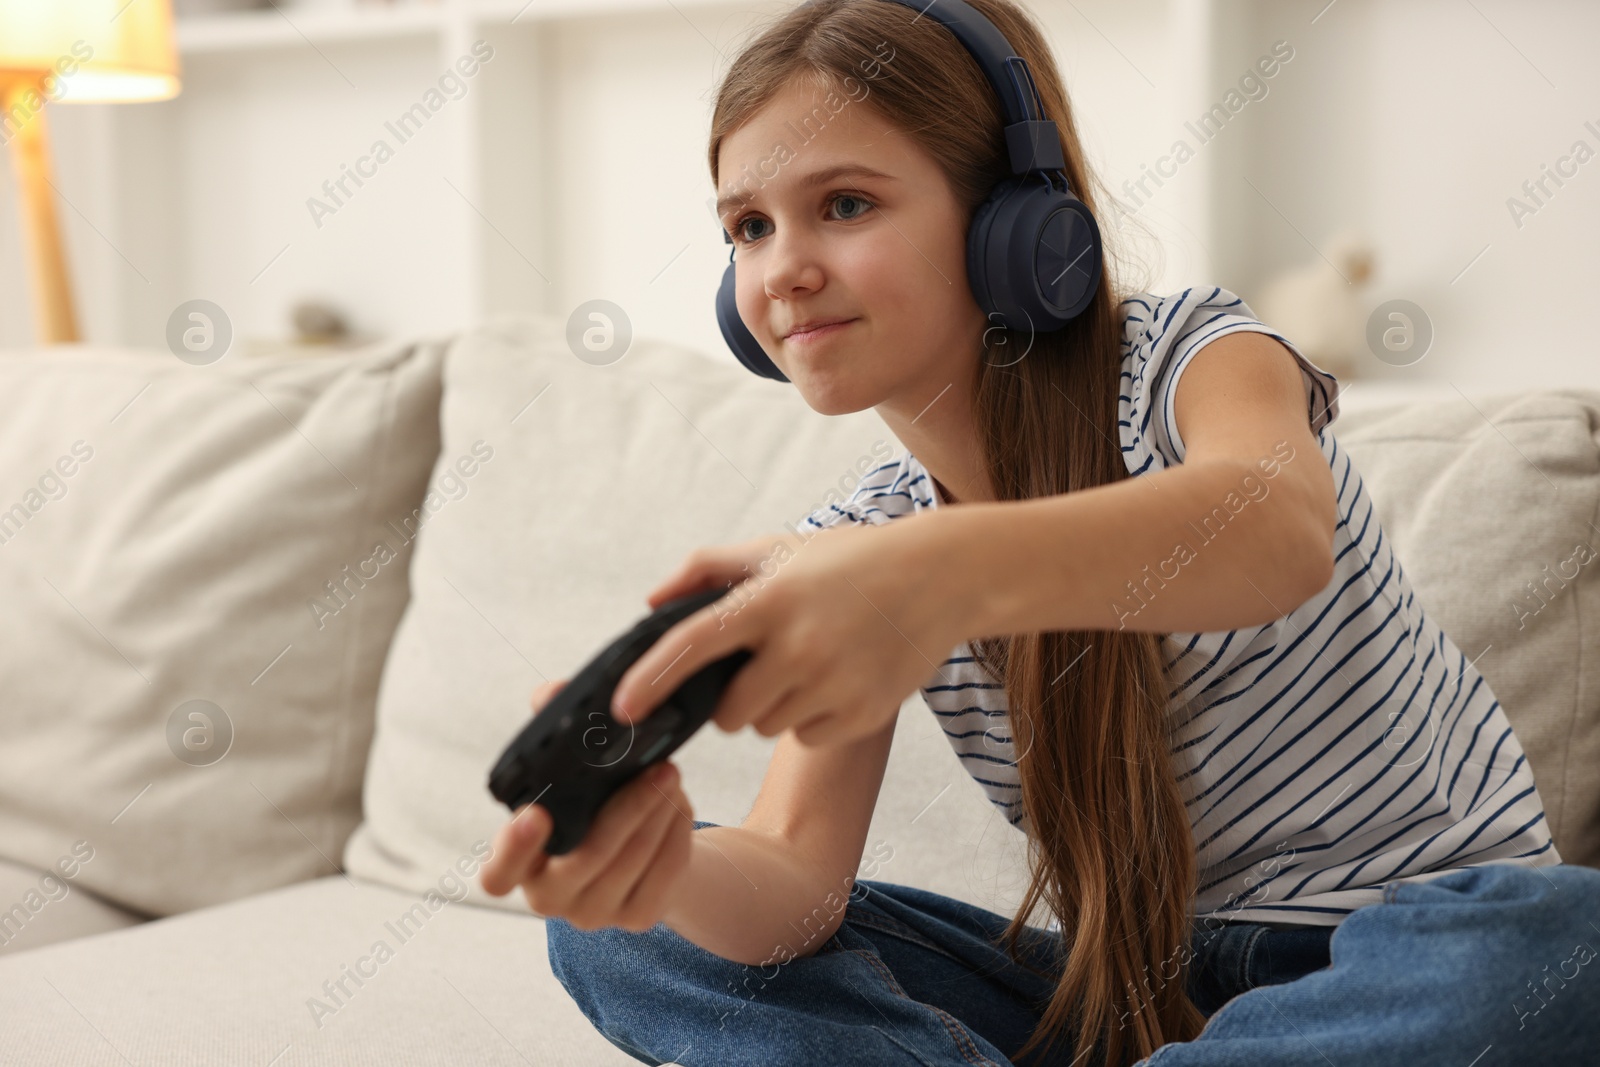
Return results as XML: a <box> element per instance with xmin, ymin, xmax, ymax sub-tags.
<box><xmin>717</xmin><ymin>73</ymin><xmax>986</xmax><ymax>419</ymax></box>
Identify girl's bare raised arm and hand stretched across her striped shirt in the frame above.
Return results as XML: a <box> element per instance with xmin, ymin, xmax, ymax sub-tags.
<box><xmin>613</xmin><ymin>333</ymin><xmax>1338</xmax><ymax>744</ymax></box>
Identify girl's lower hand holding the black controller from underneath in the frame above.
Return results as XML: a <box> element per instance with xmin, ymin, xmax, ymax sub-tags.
<box><xmin>478</xmin><ymin>680</ymin><xmax>694</xmax><ymax>933</ymax></box>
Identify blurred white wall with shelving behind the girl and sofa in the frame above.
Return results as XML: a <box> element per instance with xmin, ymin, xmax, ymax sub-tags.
<box><xmin>0</xmin><ymin>0</ymin><xmax>1600</xmax><ymax>389</ymax></box>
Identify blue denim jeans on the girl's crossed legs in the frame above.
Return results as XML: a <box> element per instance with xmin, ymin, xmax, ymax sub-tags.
<box><xmin>546</xmin><ymin>821</ymin><xmax>1600</xmax><ymax>1067</ymax></box>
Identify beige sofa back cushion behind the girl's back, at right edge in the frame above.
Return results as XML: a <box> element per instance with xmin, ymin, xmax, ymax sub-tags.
<box><xmin>1334</xmin><ymin>391</ymin><xmax>1600</xmax><ymax>867</ymax></box>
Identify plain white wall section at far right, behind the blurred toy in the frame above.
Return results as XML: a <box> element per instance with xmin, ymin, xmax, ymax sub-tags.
<box><xmin>1218</xmin><ymin>0</ymin><xmax>1600</xmax><ymax>392</ymax></box>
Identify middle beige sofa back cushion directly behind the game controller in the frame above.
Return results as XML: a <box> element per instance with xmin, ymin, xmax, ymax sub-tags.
<box><xmin>346</xmin><ymin>320</ymin><xmax>1026</xmax><ymax>913</ymax></box>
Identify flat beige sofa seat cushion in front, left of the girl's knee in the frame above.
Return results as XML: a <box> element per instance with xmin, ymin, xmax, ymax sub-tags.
<box><xmin>0</xmin><ymin>857</ymin><xmax>635</xmax><ymax>1067</ymax></box>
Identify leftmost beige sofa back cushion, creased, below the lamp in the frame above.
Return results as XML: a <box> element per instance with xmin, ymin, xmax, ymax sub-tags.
<box><xmin>0</xmin><ymin>344</ymin><xmax>442</xmax><ymax>915</ymax></box>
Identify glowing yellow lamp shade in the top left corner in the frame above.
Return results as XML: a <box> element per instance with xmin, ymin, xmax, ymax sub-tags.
<box><xmin>0</xmin><ymin>0</ymin><xmax>178</xmax><ymax>102</ymax></box>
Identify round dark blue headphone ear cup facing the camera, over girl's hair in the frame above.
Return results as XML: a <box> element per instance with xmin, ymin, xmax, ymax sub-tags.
<box><xmin>966</xmin><ymin>174</ymin><xmax>1102</xmax><ymax>333</ymax></box>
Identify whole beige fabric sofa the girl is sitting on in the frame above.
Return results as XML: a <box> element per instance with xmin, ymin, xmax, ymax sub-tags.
<box><xmin>0</xmin><ymin>320</ymin><xmax>1600</xmax><ymax>1067</ymax></box>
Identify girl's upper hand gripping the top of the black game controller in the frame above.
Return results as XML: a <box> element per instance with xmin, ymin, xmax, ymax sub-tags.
<box><xmin>613</xmin><ymin>515</ymin><xmax>981</xmax><ymax>744</ymax></box>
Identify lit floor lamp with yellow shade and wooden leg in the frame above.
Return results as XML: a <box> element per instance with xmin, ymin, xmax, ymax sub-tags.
<box><xmin>0</xmin><ymin>0</ymin><xmax>178</xmax><ymax>344</ymax></box>
